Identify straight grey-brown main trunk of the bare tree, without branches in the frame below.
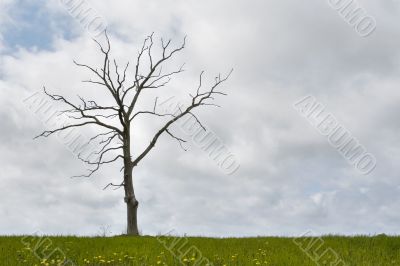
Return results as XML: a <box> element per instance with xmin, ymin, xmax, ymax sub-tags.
<box><xmin>124</xmin><ymin>129</ymin><xmax>139</xmax><ymax>236</ymax></box>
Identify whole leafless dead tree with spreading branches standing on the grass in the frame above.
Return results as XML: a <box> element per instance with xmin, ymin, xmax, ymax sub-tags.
<box><xmin>36</xmin><ymin>34</ymin><xmax>232</xmax><ymax>235</ymax></box>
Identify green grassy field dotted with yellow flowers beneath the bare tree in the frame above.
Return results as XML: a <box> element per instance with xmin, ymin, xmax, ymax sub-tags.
<box><xmin>0</xmin><ymin>236</ymin><xmax>400</xmax><ymax>266</ymax></box>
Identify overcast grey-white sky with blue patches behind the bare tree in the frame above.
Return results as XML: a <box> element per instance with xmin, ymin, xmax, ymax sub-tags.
<box><xmin>0</xmin><ymin>0</ymin><xmax>400</xmax><ymax>237</ymax></box>
